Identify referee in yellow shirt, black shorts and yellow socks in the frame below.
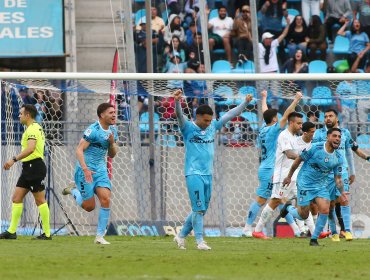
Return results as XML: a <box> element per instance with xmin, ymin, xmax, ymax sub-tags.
<box><xmin>0</xmin><ymin>104</ymin><xmax>51</xmax><ymax>240</ymax></box>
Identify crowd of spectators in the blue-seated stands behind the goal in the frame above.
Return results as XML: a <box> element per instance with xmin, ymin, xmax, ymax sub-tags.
<box><xmin>129</xmin><ymin>0</ymin><xmax>370</xmax><ymax>143</ymax></box>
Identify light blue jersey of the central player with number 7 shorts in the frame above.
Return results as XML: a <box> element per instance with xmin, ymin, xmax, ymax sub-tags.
<box><xmin>181</xmin><ymin>120</ymin><xmax>222</xmax><ymax>176</ymax></box>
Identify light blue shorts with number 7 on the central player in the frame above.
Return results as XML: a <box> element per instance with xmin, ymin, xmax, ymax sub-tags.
<box><xmin>186</xmin><ymin>175</ymin><xmax>212</xmax><ymax>213</ymax></box>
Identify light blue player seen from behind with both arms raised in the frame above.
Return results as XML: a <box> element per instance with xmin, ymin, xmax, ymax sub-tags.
<box><xmin>243</xmin><ymin>91</ymin><xmax>302</xmax><ymax>237</ymax></box>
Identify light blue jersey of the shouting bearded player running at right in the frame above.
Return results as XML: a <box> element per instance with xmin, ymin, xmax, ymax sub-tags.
<box><xmin>297</xmin><ymin>142</ymin><xmax>343</xmax><ymax>190</ymax></box>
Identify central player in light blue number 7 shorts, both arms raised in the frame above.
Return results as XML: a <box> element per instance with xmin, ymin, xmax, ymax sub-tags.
<box><xmin>173</xmin><ymin>89</ymin><xmax>253</xmax><ymax>250</ymax></box>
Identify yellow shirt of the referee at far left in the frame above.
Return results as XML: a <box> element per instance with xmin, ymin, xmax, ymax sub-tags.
<box><xmin>21</xmin><ymin>122</ymin><xmax>45</xmax><ymax>162</ymax></box>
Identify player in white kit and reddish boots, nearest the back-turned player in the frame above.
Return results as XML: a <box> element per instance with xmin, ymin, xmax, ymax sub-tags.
<box><xmin>252</xmin><ymin>112</ymin><xmax>315</xmax><ymax>239</ymax></box>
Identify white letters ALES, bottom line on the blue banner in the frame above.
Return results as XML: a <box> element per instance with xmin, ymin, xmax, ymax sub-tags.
<box><xmin>0</xmin><ymin>26</ymin><xmax>54</xmax><ymax>39</ymax></box>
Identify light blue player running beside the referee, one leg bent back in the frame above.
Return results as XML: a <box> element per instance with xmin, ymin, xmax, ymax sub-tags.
<box><xmin>63</xmin><ymin>103</ymin><xmax>118</xmax><ymax>245</ymax></box>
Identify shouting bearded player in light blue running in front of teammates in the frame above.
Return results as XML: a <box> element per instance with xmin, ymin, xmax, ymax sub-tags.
<box><xmin>280</xmin><ymin>128</ymin><xmax>348</xmax><ymax>246</ymax></box>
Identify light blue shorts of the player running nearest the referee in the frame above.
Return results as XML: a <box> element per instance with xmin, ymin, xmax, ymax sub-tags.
<box><xmin>75</xmin><ymin>167</ymin><xmax>112</xmax><ymax>200</ymax></box>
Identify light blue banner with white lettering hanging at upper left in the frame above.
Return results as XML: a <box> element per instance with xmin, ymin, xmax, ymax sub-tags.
<box><xmin>0</xmin><ymin>0</ymin><xmax>64</xmax><ymax>57</ymax></box>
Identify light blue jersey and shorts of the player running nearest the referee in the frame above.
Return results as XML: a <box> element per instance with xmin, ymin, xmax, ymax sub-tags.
<box><xmin>75</xmin><ymin>121</ymin><xmax>118</xmax><ymax>200</ymax></box>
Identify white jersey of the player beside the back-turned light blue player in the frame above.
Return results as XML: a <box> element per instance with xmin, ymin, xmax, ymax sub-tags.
<box><xmin>272</xmin><ymin>128</ymin><xmax>298</xmax><ymax>183</ymax></box>
